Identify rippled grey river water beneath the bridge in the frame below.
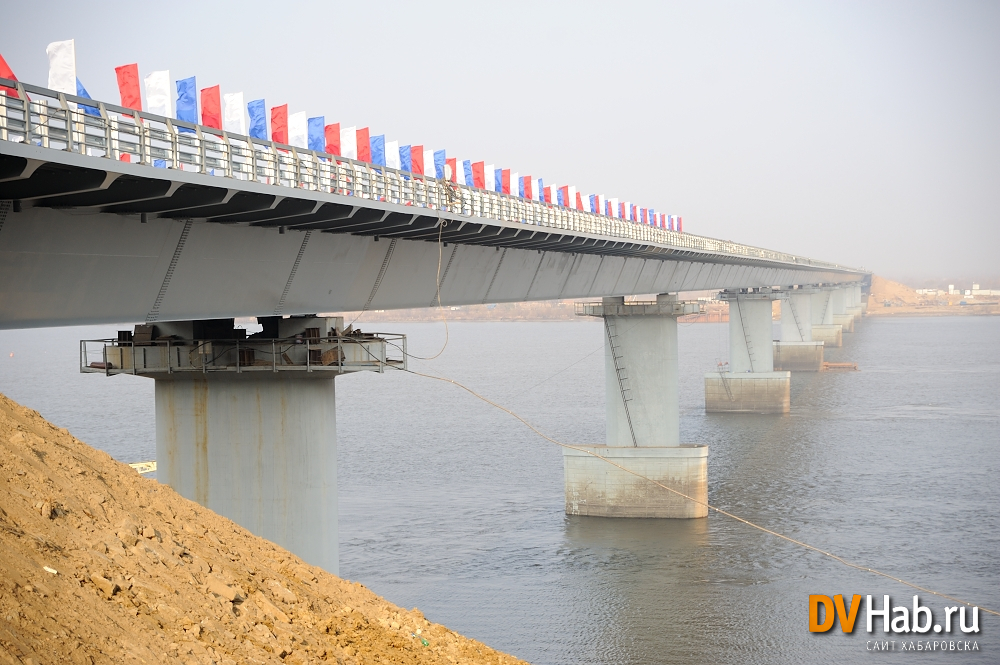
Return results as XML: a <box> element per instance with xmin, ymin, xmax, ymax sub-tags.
<box><xmin>0</xmin><ymin>317</ymin><xmax>1000</xmax><ymax>664</ymax></box>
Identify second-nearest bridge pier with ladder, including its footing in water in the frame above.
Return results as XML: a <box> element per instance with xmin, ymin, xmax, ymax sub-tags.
<box><xmin>563</xmin><ymin>295</ymin><xmax>708</xmax><ymax>518</ymax></box>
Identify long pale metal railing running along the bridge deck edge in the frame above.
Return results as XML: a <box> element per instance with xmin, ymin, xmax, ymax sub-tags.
<box><xmin>0</xmin><ymin>78</ymin><xmax>854</xmax><ymax>271</ymax></box>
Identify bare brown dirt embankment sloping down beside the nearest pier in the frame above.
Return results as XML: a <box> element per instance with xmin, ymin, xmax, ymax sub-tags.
<box><xmin>0</xmin><ymin>395</ymin><xmax>521</xmax><ymax>665</ymax></box>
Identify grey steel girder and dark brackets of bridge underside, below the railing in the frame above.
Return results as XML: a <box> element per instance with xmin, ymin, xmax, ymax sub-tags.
<box><xmin>0</xmin><ymin>144</ymin><xmax>863</xmax><ymax>328</ymax></box>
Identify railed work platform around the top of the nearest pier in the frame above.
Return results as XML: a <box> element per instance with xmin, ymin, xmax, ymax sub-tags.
<box><xmin>80</xmin><ymin>333</ymin><xmax>407</xmax><ymax>376</ymax></box>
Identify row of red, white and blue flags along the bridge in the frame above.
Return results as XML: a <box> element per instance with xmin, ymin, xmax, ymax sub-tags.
<box><xmin>0</xmin><ymin>39</ymin><xmax>683</xmax><ymax>231</ymax></box>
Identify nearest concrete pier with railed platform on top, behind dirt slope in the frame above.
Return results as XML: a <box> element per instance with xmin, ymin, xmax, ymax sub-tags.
<box><xmin>81</xmin><ymin>316</ymin><xmax>405</xmax><ymax>574</ymax></box>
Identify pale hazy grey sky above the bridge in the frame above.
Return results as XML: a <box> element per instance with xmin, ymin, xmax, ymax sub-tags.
<box><xmin>0</xmin><ymin>0</ymin><xmax>1000</xmax><ymax>288</ymax></box>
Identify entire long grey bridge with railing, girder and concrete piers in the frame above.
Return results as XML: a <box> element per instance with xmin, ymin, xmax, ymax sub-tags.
<box><xmin>0</xmin><ymin>79</ymin><xmax>870</xmax><ymax>572</ymax></box>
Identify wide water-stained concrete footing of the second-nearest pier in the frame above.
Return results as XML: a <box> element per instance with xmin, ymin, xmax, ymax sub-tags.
<box><xmin>563</xmin><ymin>445</ymin><xmax>708</xmax><ymax>518</ymax></box>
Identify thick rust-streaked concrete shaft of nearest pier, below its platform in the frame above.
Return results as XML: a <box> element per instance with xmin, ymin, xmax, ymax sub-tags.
<box><xmin>156</xmin><ymin>372</ymin><xmax>339</xmax><ymax>575</ymax></box>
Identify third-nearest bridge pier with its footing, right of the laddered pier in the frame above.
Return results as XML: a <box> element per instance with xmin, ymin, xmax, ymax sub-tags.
<box><xmin>705</xmin><ymin>288</ymin><xmax>792</xmax><ymax>413</ymax></box>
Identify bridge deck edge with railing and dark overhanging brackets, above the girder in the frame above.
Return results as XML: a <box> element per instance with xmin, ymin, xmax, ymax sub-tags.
<box><xmin>0</xmin><ymin>79</ymin><xmax>854</xmax><ymax>273</ymax></box>
